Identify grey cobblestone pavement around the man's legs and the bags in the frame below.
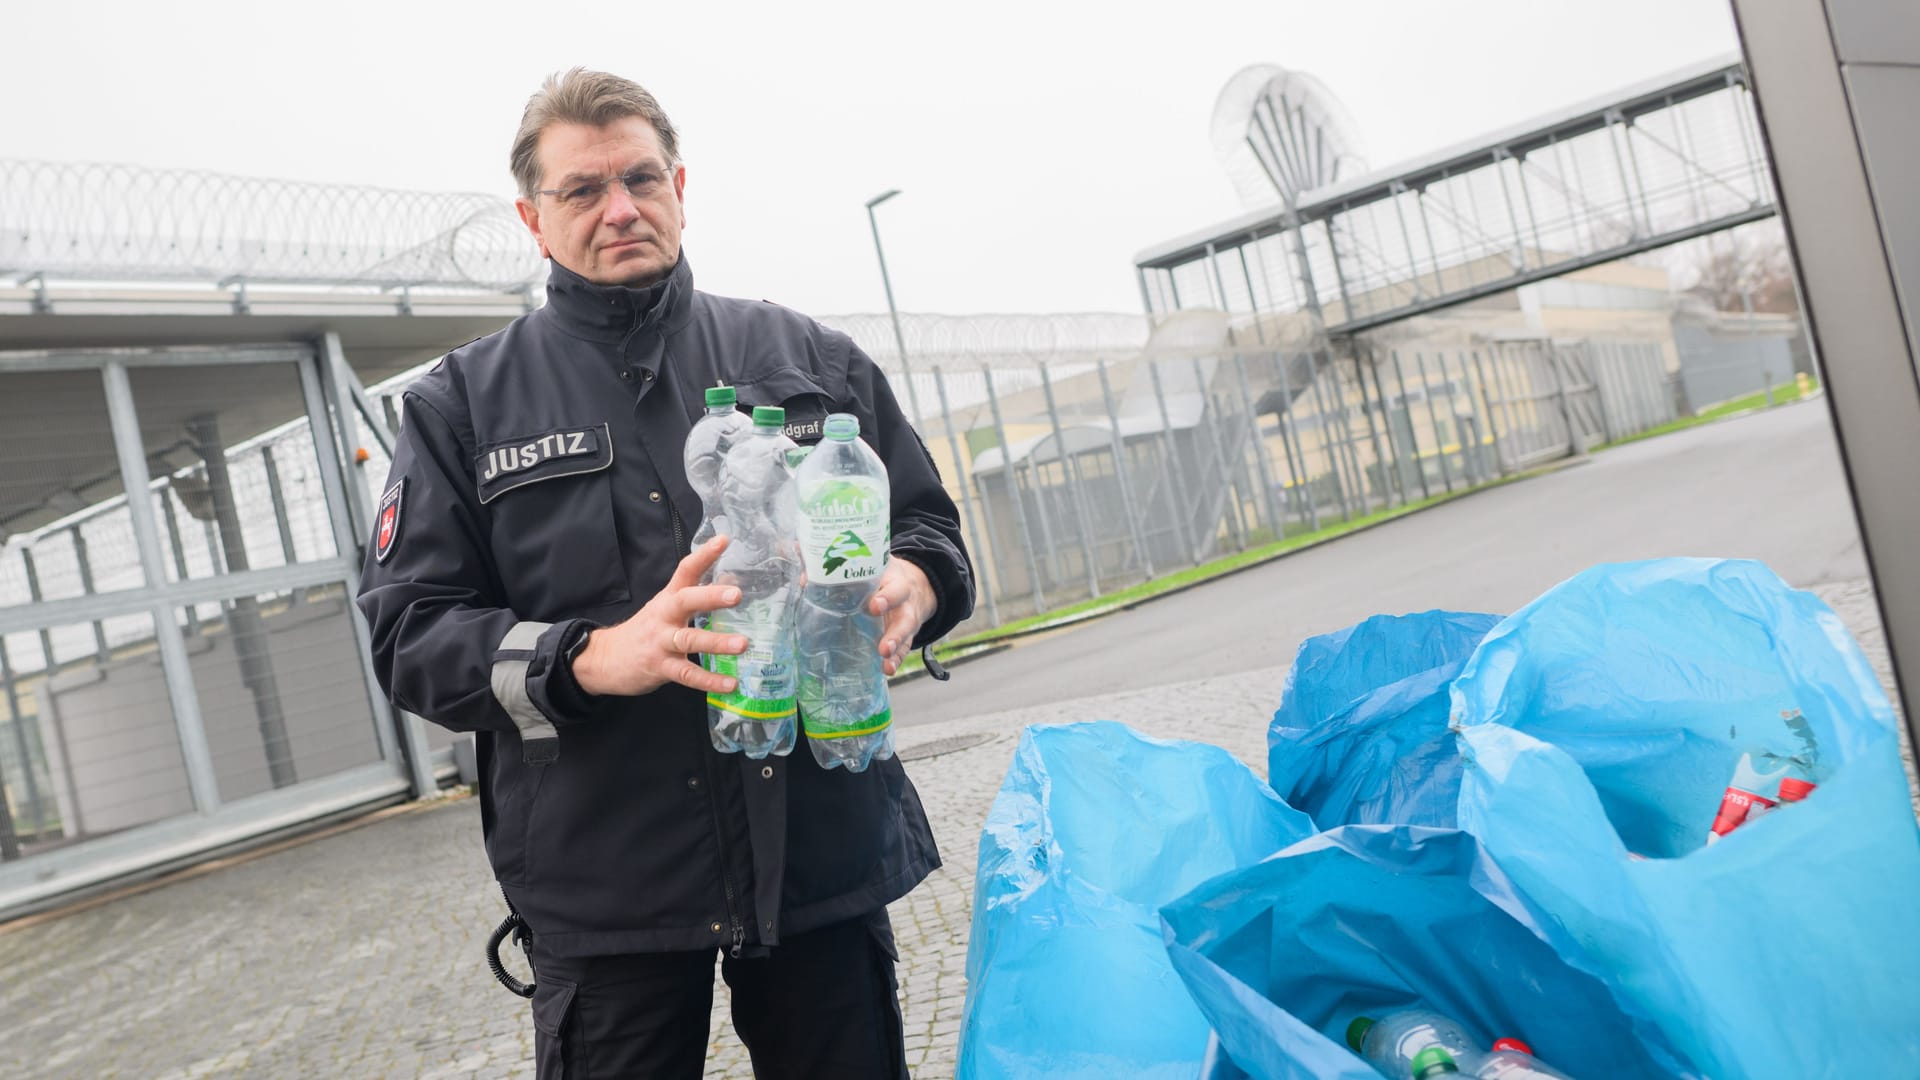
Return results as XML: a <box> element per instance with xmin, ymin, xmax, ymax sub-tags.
<box><xmin>0</xmin><ymin>582</ymin><xmax>1887</xmax><ymax>1080</ymax></box>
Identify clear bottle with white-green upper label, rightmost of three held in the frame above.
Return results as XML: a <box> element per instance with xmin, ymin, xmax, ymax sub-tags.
<box><xmin>793</xmin><ymin>413</ymin><xmax>893</xmax><ymax>773</ymax></box>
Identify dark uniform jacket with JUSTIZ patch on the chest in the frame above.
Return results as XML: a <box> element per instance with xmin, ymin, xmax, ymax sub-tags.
<box><xmin>359</xmin><ymin>258</ymin><xmax>973</xmax><ymax>955</ymax></box>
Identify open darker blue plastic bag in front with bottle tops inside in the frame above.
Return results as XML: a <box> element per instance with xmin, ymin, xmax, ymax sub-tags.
<box><xmin>1162</xmin><ymin>826</ymin><xmax>1692</xmax><ymax>1080</ymax></box>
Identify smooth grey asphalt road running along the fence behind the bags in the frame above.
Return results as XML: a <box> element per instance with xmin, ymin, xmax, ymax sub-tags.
<box><xmin>895</xmin><ymin>400</ymin><xmax>1866</xmax><ymax>724</ymax></box>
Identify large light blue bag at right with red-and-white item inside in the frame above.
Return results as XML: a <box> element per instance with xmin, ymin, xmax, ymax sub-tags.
<box><xmin>1453</xmin><ymin>559</ymin><xmax>1920</xmax><ymax>1078</ymax></box>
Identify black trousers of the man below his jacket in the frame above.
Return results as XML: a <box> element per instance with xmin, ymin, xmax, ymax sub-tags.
<box><xmin>534</xmin><ymin>909</ymin><xmax>908</xmax><ymax>1080</ymax></box>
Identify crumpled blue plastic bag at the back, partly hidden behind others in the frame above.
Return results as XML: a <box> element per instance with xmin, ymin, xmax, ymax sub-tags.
<box><xmin>1267</xmin><ymin>611</ymin><xmax>1500</xmax><ymax>828</ymax></box>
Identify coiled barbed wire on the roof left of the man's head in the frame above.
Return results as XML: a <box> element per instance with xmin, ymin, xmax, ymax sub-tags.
<box><xmin>0</xmin><ymin>160</ymin><xmax>543</xmax><ymax>292</ymax></box>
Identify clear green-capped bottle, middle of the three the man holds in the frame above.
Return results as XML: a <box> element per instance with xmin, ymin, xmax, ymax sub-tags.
<box><xmin>705</xmin><ymin>405</ymin><xmax>801</xmax><ymax>757</ymax></box>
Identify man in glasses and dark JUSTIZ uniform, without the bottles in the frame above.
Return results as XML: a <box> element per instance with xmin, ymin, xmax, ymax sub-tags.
<box><xmin>359</xmin><ymin>69</ymin><xmax>973</xmax><ymax>1078</ymax></box>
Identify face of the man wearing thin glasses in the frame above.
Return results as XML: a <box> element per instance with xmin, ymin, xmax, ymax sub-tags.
<box><xmin>515</xmin><ymin>115</ymin><xmax>687</xmax><ymax>288</ymax></box>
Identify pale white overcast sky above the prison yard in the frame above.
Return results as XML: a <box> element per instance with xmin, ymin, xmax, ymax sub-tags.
<box><xmin>0</xmin><ymin>0</ymin><xmax>1738</xmax><ymax>315</ymax></box>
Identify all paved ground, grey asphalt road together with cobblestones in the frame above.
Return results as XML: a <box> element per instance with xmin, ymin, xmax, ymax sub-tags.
<box><xmin>0</xmin><ymin>397</ymin><xmax>1885</xmax><ymax>1080</ymax></box>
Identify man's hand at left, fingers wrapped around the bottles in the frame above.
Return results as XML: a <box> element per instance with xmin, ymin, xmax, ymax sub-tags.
<box><xmin>574</xmin><ymin>536</ymin><xmax>747</xmax><ymax>698</ymax></box>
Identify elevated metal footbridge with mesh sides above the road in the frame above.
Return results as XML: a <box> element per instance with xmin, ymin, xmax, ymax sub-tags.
<box><xmin>1135</xmin><ymin>60</ymin><xmax>1774</xmax><ymax>334</ymax></box>
